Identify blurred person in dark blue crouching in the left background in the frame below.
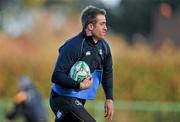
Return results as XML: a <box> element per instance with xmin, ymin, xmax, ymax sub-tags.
<box><xmin>6</xmin><ymin>76</ymin><xmax>49</xmax><ymax>122</ymax></box>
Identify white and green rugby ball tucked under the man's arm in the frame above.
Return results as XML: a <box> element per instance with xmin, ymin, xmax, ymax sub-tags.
<box><xmin>69</xmin><ymin>61</ymin><xmax>91</xmax><ymax>82</ymax></box>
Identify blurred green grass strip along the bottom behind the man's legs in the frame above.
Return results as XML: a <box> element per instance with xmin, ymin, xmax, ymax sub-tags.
<box><xmin>0</xmin><ymin>100</ymin><xmax>180</xmax><ymax>122</ymax></box>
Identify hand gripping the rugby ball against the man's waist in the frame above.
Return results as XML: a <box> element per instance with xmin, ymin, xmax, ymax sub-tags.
<box><xmin>80</xmin><ymin>76</ymin><xmax>93</xmax><ymax>90</ymax></box>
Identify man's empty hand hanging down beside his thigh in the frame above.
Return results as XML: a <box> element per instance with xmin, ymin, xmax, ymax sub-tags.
<box><xmin>104</xmin><ymin>99</ymin><xmax>114</xmax><ymax>121</ymax></box>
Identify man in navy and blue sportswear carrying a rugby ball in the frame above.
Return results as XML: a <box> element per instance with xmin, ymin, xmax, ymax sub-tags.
<box><xmin>50</xmin><ymin>6</ymin><xmax>113</xmax><ymax>122</ymax></box>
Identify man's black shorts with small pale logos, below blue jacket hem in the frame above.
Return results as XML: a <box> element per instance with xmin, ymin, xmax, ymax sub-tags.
<box><xmin>50</xmin><ymin>90</ymin><xmax>96</xmax><ymax>122</ymax></box>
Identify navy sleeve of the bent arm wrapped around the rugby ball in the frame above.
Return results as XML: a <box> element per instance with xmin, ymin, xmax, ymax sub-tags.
<box><xmin>51</xmin><ymin>45</ymin><xmax>80</xmax><ymax>89</ymax></box>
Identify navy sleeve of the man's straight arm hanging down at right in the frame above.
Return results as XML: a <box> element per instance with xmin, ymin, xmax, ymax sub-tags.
<box><xmin>102</xmin><ymin>43</ymin><xmax>113</xmax><ymax>100</ymax></box>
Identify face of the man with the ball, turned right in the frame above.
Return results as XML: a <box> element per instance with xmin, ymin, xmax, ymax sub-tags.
<box><xmin>92</xmin><ymin>14</ymin><xmax>107</xmax><ymax>40</ymax></box>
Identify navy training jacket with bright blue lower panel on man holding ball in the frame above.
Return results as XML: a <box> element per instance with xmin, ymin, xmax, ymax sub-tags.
<box><xmin>51</xmin><ymin>32</ymin><xmax>113</xmax><ymax>99</ymax></box>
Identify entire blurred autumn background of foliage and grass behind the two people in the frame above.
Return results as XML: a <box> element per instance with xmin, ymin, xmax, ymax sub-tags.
<box><xmin>0</xmin><ymin>0</ymin><xmax>180</xmax><ymax>122</ymax></box>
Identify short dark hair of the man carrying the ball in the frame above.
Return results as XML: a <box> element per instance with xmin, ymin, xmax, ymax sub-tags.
<box><xmin>81</xmin><ymin>5</ymin><xmax>106</xmax><ymax>28</ymax></box>
